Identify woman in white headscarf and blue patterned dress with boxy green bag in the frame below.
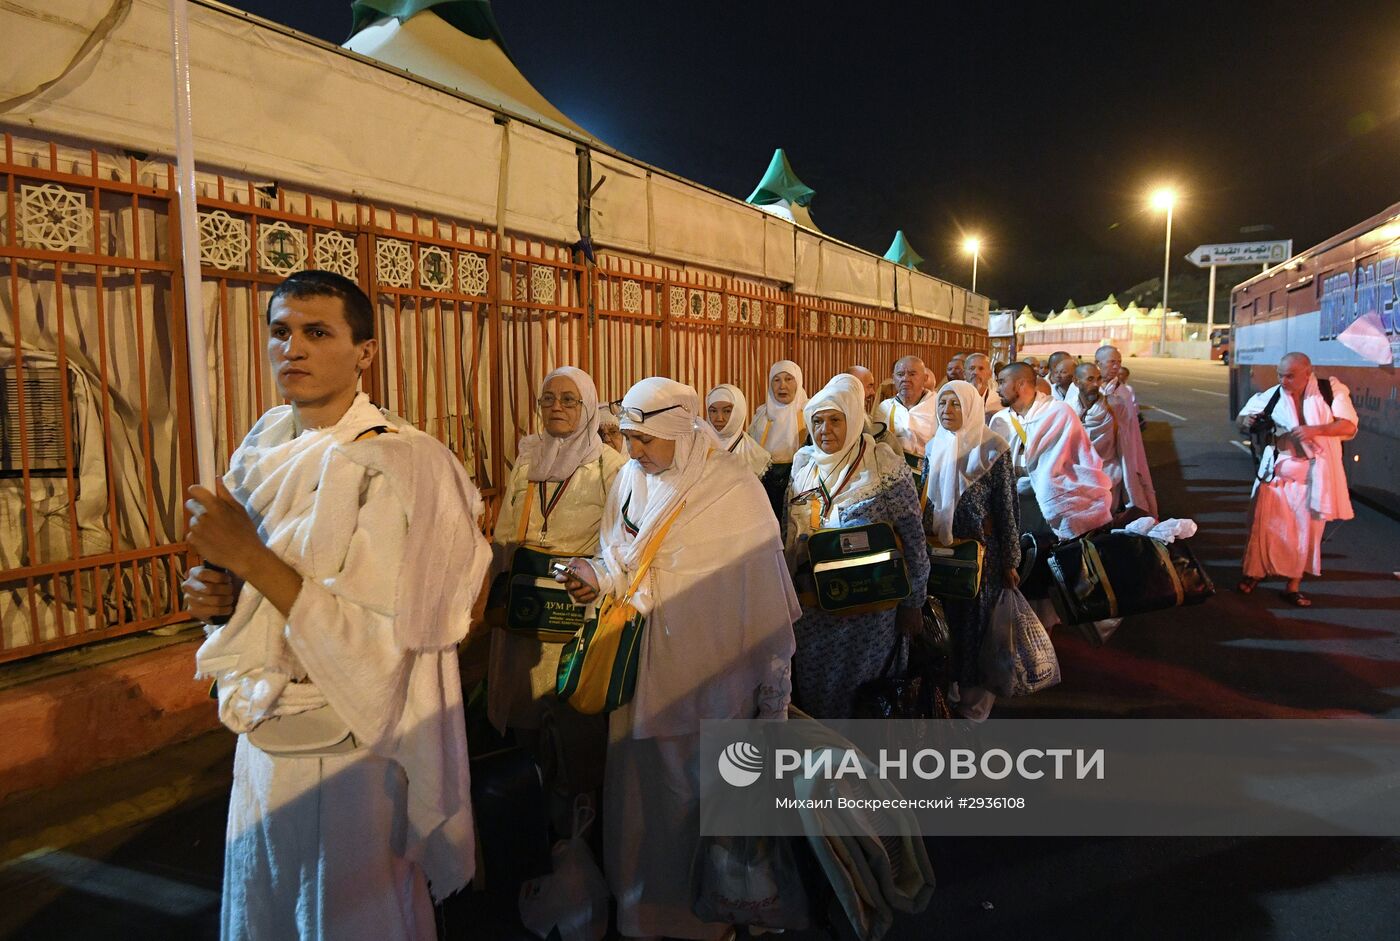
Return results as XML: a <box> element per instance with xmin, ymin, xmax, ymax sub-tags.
<box><xmin>784</xmin><ymin>374</ymin><xmax>928</xmax><ymax>718</ymax></box>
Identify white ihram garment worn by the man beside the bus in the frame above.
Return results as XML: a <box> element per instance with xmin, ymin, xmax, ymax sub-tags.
<box><xmin>1239</xmin><ymin>378</ymin><xmax>1357</xmax><ymax>578</ymax></box>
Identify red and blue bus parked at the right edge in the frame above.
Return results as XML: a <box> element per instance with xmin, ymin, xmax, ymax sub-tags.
<box><xmin>1229</xmin><ymin>203</ymin><xmax>1400</xmax><ymax>515</ymax></box>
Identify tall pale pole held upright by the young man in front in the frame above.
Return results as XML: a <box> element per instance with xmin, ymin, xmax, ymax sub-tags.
<box><xmin>171</xmin><ymin>0</ymin><xmax>216</xmax><ymax>487</ymax></box>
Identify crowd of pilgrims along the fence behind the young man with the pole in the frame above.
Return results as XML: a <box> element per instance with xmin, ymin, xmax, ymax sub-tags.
<box><xmin>486</xmin><ymin>341</ymin><xmax>1156</xmax><ymax>938</ymax></box>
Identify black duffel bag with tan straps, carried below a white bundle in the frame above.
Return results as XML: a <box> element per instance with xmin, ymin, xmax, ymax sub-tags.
<box><xmin>1046</xmin><ymin>532</ymin><xmax>1215</xmax><ymax>643</ymax></box>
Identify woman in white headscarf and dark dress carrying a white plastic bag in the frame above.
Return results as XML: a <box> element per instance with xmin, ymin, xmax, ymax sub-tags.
<box><xmin>924</xmin><ymin>379</ymin><xmax>1021</xmax><ymax>718</ymax></box>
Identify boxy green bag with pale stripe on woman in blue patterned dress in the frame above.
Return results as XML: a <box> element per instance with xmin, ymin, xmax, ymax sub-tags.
<box><xmin>806</xmin><ymin>522</ymin><xmax>911</xmax><ymax>615</ymax></box>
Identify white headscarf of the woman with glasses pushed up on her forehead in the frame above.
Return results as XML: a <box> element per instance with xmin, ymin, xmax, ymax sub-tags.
<box><xmin>609</xmin><ymin>377</ymin><xmax>722</xmax><ymax>570</ymax></box>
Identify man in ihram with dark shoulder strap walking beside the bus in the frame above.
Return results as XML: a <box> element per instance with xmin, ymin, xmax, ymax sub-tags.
<box><xmin>1239</xmin><ymin>353</ymin><xmax>1357</xmax><ymax>608</ymax></box>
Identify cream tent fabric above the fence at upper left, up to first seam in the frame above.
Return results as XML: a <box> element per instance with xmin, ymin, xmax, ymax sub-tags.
<box><xmin>0</xmin><ymin>0</ymin><xmax>501</xmax><ymax>228</ymax></box>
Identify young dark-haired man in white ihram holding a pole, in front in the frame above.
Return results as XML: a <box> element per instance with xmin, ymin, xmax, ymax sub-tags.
<box><xmin>183</xmin><ymin>272</ymin><xmax>490</xmax><ymax>941</ymax></box>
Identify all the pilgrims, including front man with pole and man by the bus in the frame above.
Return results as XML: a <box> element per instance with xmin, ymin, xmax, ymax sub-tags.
<box><xmin>182</xmin><ymin>272</ymin><xmax>1354</xmax><ymax>940</ymax></box>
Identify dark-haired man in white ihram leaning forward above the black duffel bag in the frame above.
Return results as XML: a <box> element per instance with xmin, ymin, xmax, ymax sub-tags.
<box><xmin>991</xmin><ymin>363</ymin><xmax>1113</xmax><ymax>539</ymax></box>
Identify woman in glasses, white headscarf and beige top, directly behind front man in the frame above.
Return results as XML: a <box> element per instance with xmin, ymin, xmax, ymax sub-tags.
<box><xmin>486</xmin><ymin>365</ymin><xmax>626</xmax><ymax>737</ymax></box>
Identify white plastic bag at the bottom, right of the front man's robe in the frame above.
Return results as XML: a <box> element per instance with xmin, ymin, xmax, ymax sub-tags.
<box><xmin>519</xmin><ymin>795</ymin><xmax>609</xmax><ymax>941</ymax></box>
